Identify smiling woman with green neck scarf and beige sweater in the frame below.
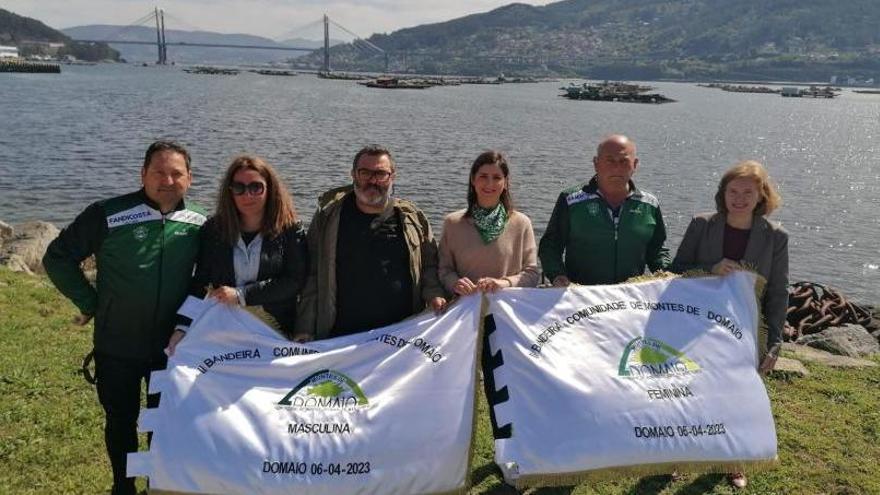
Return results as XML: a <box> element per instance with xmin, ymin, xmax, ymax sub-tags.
<box><xmin>439</xmin><ymin>151</ymin><xmax>540</xmax><ymax>296</ymax></box>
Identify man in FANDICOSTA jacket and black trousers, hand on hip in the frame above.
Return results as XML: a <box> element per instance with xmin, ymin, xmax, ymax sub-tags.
<box><xmin>43</xmin><ymin>141</ymin><xmax>205</xmax><ymax>494</ymax></box>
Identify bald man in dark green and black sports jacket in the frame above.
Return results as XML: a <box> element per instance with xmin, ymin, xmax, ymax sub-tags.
<box><xmin>538</xmin><ymin>135</ymin><xmax>669</xmax><ymax>287</ymax></box>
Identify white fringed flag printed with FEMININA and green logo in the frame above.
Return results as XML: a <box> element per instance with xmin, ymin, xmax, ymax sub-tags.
<box><xmin>486</xmin><ymin>272</ymin><xmax>776</xmax><ymax>487</ymax></box>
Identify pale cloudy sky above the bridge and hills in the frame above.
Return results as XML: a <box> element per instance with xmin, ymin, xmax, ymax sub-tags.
<box><xmin>0</xmin><ymin>0</ymin><xmax>549</xmax><ymax>39</ymax></box>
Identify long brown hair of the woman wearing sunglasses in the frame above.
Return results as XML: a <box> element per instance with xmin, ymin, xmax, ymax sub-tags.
<box><xmin>214</xmin><ymin>155</ymin><xmax>297</xmax><ymax>246</ymax></box>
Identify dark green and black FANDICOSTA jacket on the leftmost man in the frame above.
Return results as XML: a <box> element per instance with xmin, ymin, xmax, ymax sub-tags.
<box><xmin>43</xmin><ymin>189</ymin><xmax>206</xmax><ymax>360</ymax></box>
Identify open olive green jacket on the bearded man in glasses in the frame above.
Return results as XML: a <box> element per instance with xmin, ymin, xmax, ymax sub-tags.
<box><xmin>294</xmin><ymin>186</ymin><xmax>444</xmax><ymax>339</ymax></box>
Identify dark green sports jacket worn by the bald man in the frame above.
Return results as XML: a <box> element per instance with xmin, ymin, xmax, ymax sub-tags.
<box><xmin>538</xmin><ymin>177</ymin><xmax>669</xmax><ymax>285</ymax></box>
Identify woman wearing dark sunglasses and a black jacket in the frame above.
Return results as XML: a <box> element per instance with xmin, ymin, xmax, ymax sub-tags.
<box><xmin>168</xmin><ymin>155</ymin><xmax>308</xmax><ymax>354</ymax></box>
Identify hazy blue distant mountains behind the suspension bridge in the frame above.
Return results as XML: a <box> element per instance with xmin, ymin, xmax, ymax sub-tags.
<box><xmin>62</xmin><ymin>24</ymin><xmax>341</xmax><ymax>65</ymax></box>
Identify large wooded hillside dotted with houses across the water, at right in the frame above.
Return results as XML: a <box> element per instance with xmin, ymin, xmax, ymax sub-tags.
<box><xmin>298</xmin><ymin>0</ymin><xmax>880</xmax><ymax>80</ymax></box>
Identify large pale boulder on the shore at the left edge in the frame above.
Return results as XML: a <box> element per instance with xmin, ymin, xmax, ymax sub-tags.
<box><xmin>0</xmin><ymin>222</ymin><xmax>60</xmax><ymax>273</ymax></box>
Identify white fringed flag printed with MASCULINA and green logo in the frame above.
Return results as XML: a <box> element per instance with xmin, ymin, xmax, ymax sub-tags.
<box><xmin>128</xmin><ymin>296</ymin><xmax>481</xmax><ymax>494</ymax></box>
